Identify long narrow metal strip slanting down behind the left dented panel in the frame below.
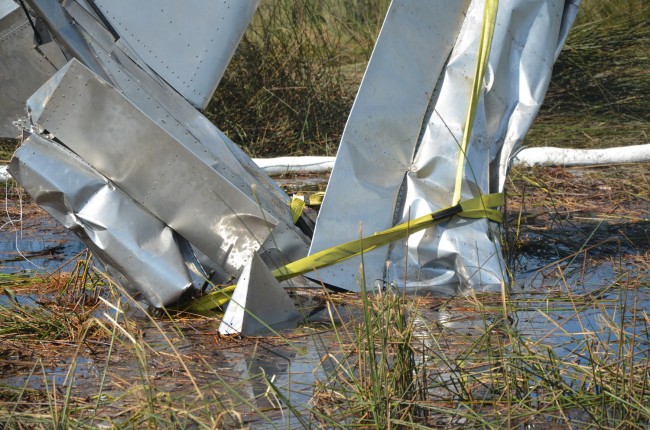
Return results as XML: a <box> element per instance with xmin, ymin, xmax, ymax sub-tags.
<box><xmin>19</xmin><ymin>0</ymin><xmax>288</xmax><ymax>220</ymax></box>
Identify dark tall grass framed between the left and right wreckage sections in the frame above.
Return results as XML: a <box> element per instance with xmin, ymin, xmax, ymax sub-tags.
<box><xmin>206</xmin><ymin>0</ymin><xmax>388</xmax><ymax>156</ymax></box>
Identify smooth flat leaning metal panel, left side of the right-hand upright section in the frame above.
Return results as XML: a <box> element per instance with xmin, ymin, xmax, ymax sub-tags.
<box><xmin>310</xmin><ymin>0</ymin><xmax>469</xmax><ymax>289</ymax></box>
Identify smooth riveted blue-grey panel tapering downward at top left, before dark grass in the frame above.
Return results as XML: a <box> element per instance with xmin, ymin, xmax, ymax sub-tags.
<box><xmin>95</xmin><ymin>0</ymin><xmax>259</xmax><ymax>108</ymax></box>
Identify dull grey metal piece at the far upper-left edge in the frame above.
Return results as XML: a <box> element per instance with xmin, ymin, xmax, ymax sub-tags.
<box><xmin>0</xmin><ymin>0</ymin><xmax>67</xmax><ymax>138</ymax></box>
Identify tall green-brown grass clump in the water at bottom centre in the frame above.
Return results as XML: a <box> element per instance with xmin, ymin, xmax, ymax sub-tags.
<box><xmin>314</xmin><ymin>282</ymin><xmax>425</xmax><ymax>428</ymax></box>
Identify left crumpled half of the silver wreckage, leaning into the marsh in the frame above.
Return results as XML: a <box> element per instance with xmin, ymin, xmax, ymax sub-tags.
<box><xmin>2</xmin><ymin>0</ymin><xmax>311</xmax><ymax>307</ymax></box>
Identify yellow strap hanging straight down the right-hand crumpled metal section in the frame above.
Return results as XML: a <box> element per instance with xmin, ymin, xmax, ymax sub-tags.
<box><xmin>451</xmin><ymin>0</ymin><xmax>499</xmax><ymax>205</ymax></box>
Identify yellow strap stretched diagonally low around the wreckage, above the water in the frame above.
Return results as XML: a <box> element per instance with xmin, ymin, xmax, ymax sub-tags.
<box><xmin>183</xmin><ymin>193</ymin><xmax>504</xmax><ymax>312</ymax></box>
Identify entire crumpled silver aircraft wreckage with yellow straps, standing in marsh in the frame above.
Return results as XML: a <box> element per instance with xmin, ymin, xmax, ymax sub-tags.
<box><xmin>0</xmin><ymin>0</ymin><xmax>579</xmax><ymax>334</ymax></box>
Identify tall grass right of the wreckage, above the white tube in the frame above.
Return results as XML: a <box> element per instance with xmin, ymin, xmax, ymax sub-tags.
<box><xmin>525</xmin><ymin>0</ymin><xmax>650</xmax><ymax>148</ymax></box>
